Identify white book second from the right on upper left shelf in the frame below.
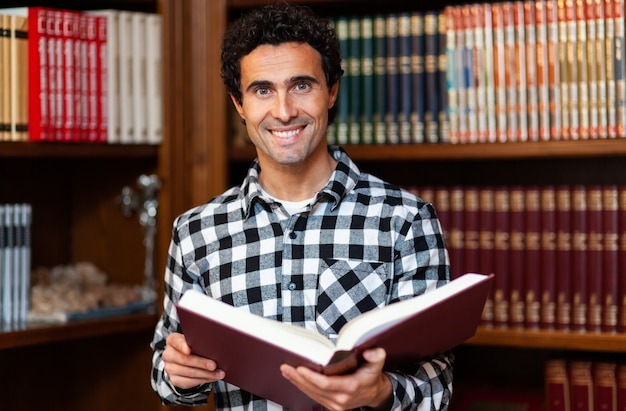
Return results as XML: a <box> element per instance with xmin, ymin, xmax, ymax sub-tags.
<box><xmin>131</xmin><ymin>12</ymin><xmax>148</xmax><ymax>144</ymax></box>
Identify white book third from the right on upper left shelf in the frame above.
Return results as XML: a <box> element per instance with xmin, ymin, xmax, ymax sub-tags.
<box><xmin>118</xmin><ymin>11</ymin><xmax>135</xmax><ymax>144</ymax></box>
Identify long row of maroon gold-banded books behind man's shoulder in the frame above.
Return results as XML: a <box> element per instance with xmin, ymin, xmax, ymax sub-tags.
<box><xmin>409</xmin><ymin>185</ymin><xmax>626</xmax><ymax>332</ymax></box>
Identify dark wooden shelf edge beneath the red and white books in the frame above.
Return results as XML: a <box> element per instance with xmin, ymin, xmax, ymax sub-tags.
<box><xmin>0</xmin><ymin>142</ymin><xmax>159</xmax><ymax>158</ymax></box>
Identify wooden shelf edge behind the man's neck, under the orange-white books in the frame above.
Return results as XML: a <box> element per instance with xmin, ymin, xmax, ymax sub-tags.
<box><xmin>230</xmin><ymin>138</ymin><xmax>626</xmax><ymax>161</ymax></box>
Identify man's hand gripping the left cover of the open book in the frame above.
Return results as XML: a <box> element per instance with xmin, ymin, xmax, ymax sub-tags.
<box><xmin>162</xmin><ymin>333</ymin><xmax>225</xmax><ymax>389</ymax></box>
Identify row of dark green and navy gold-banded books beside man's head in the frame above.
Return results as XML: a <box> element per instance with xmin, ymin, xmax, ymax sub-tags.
<box><xmin>328</xmin><ymin>11</ymin><xmax>448</xmax><ymax>144</ymax></box>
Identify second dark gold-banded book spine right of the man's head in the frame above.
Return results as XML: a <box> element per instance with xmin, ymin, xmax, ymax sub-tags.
<box><xmin>348</xmin><ymin>17</ymin><xmax>363</xmax><ymax>144</ymax></box>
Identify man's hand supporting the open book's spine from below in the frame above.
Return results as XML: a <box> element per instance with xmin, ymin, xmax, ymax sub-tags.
<box><xmin>280</xmin><ymin>348</ymin><xmax>393</xmax><ymax>410</ymax></box>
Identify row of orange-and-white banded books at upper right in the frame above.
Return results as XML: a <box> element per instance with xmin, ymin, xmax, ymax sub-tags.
<box><xmin>445</xmin><ymin>0</ymin><xmax>626</xmax><ymax>143</ymax></box>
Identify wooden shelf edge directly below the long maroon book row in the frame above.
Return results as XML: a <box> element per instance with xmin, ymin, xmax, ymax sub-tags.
<box><xmin>466</xmin><ymin>327</ymin><xmax>626</xmax><ymax>352</ymax></box>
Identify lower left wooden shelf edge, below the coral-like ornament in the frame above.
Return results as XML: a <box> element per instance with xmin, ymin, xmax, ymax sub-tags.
<box><xmin>0</xmin><ymin>312</ymin><xmax>157</xmax><ymax>350</ymax></box>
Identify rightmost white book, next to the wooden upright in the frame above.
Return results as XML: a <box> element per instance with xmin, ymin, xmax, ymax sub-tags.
<box><xmin>145</xmin><ymin>14</ymin><xmax>163</xmax><ymax>144</ymax></box>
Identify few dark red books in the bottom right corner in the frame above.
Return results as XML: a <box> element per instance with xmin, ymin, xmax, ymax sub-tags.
<box><xmin>544</xmin><ymin>358</ymin><xmax>626</xmax><ymax>411</ymax></box>
